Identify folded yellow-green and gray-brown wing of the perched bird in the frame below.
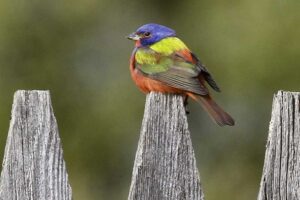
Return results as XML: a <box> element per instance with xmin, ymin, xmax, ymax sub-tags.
<box><xmin>135</xmin><ymin>48</ymin><xmax>208</xmax><ymax>95</ymax></box>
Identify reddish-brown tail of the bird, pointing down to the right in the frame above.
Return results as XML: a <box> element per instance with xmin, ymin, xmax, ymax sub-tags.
<box><xmin>188</xmin><ymin>93</ymin><xmax>234</xmax><ymax>126</ymax></box>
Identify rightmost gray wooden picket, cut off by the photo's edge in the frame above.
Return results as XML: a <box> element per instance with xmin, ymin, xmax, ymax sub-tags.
<box><xmin>258</xmin><ymin>91</ymin><xmax>300</xmax><ymax>200</ymax></box>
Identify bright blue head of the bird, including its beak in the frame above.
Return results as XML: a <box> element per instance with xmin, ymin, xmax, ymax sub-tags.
<box><xmin>128</xmin><ymin>23</ymin><xmax>176</xmax><ymax>46</ymax></box>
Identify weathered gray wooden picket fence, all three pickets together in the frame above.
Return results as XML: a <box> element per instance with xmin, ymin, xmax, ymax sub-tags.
<box><xmin>0</xmin><ymin>91</ymin><xmax>300</xmax><ymax>200</ymax></box>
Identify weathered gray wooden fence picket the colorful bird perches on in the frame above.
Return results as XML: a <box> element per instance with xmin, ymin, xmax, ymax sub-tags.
<box><xmin>128</xmin><ymin>92</ymin><xmax>204</xmax><ymax>200</ymax></box>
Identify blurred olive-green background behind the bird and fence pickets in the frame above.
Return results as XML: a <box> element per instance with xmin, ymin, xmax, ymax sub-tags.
<box><xmin>0</xmin><ymin>0</ymin><xmax>300</xmax><ymax>200</ymax></box>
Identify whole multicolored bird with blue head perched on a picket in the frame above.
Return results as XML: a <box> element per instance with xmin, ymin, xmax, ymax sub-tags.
<box><xmin>127</xmin><ymin>23</ymin><xmax>235</xmax><ymax>126</ymax></box>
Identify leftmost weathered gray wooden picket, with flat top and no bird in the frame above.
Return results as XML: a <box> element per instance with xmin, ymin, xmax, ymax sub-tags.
<box><xmin>0</xmin><ymin>91</ymin><xmax>72</xmax><ymax>200</ymax></box>
